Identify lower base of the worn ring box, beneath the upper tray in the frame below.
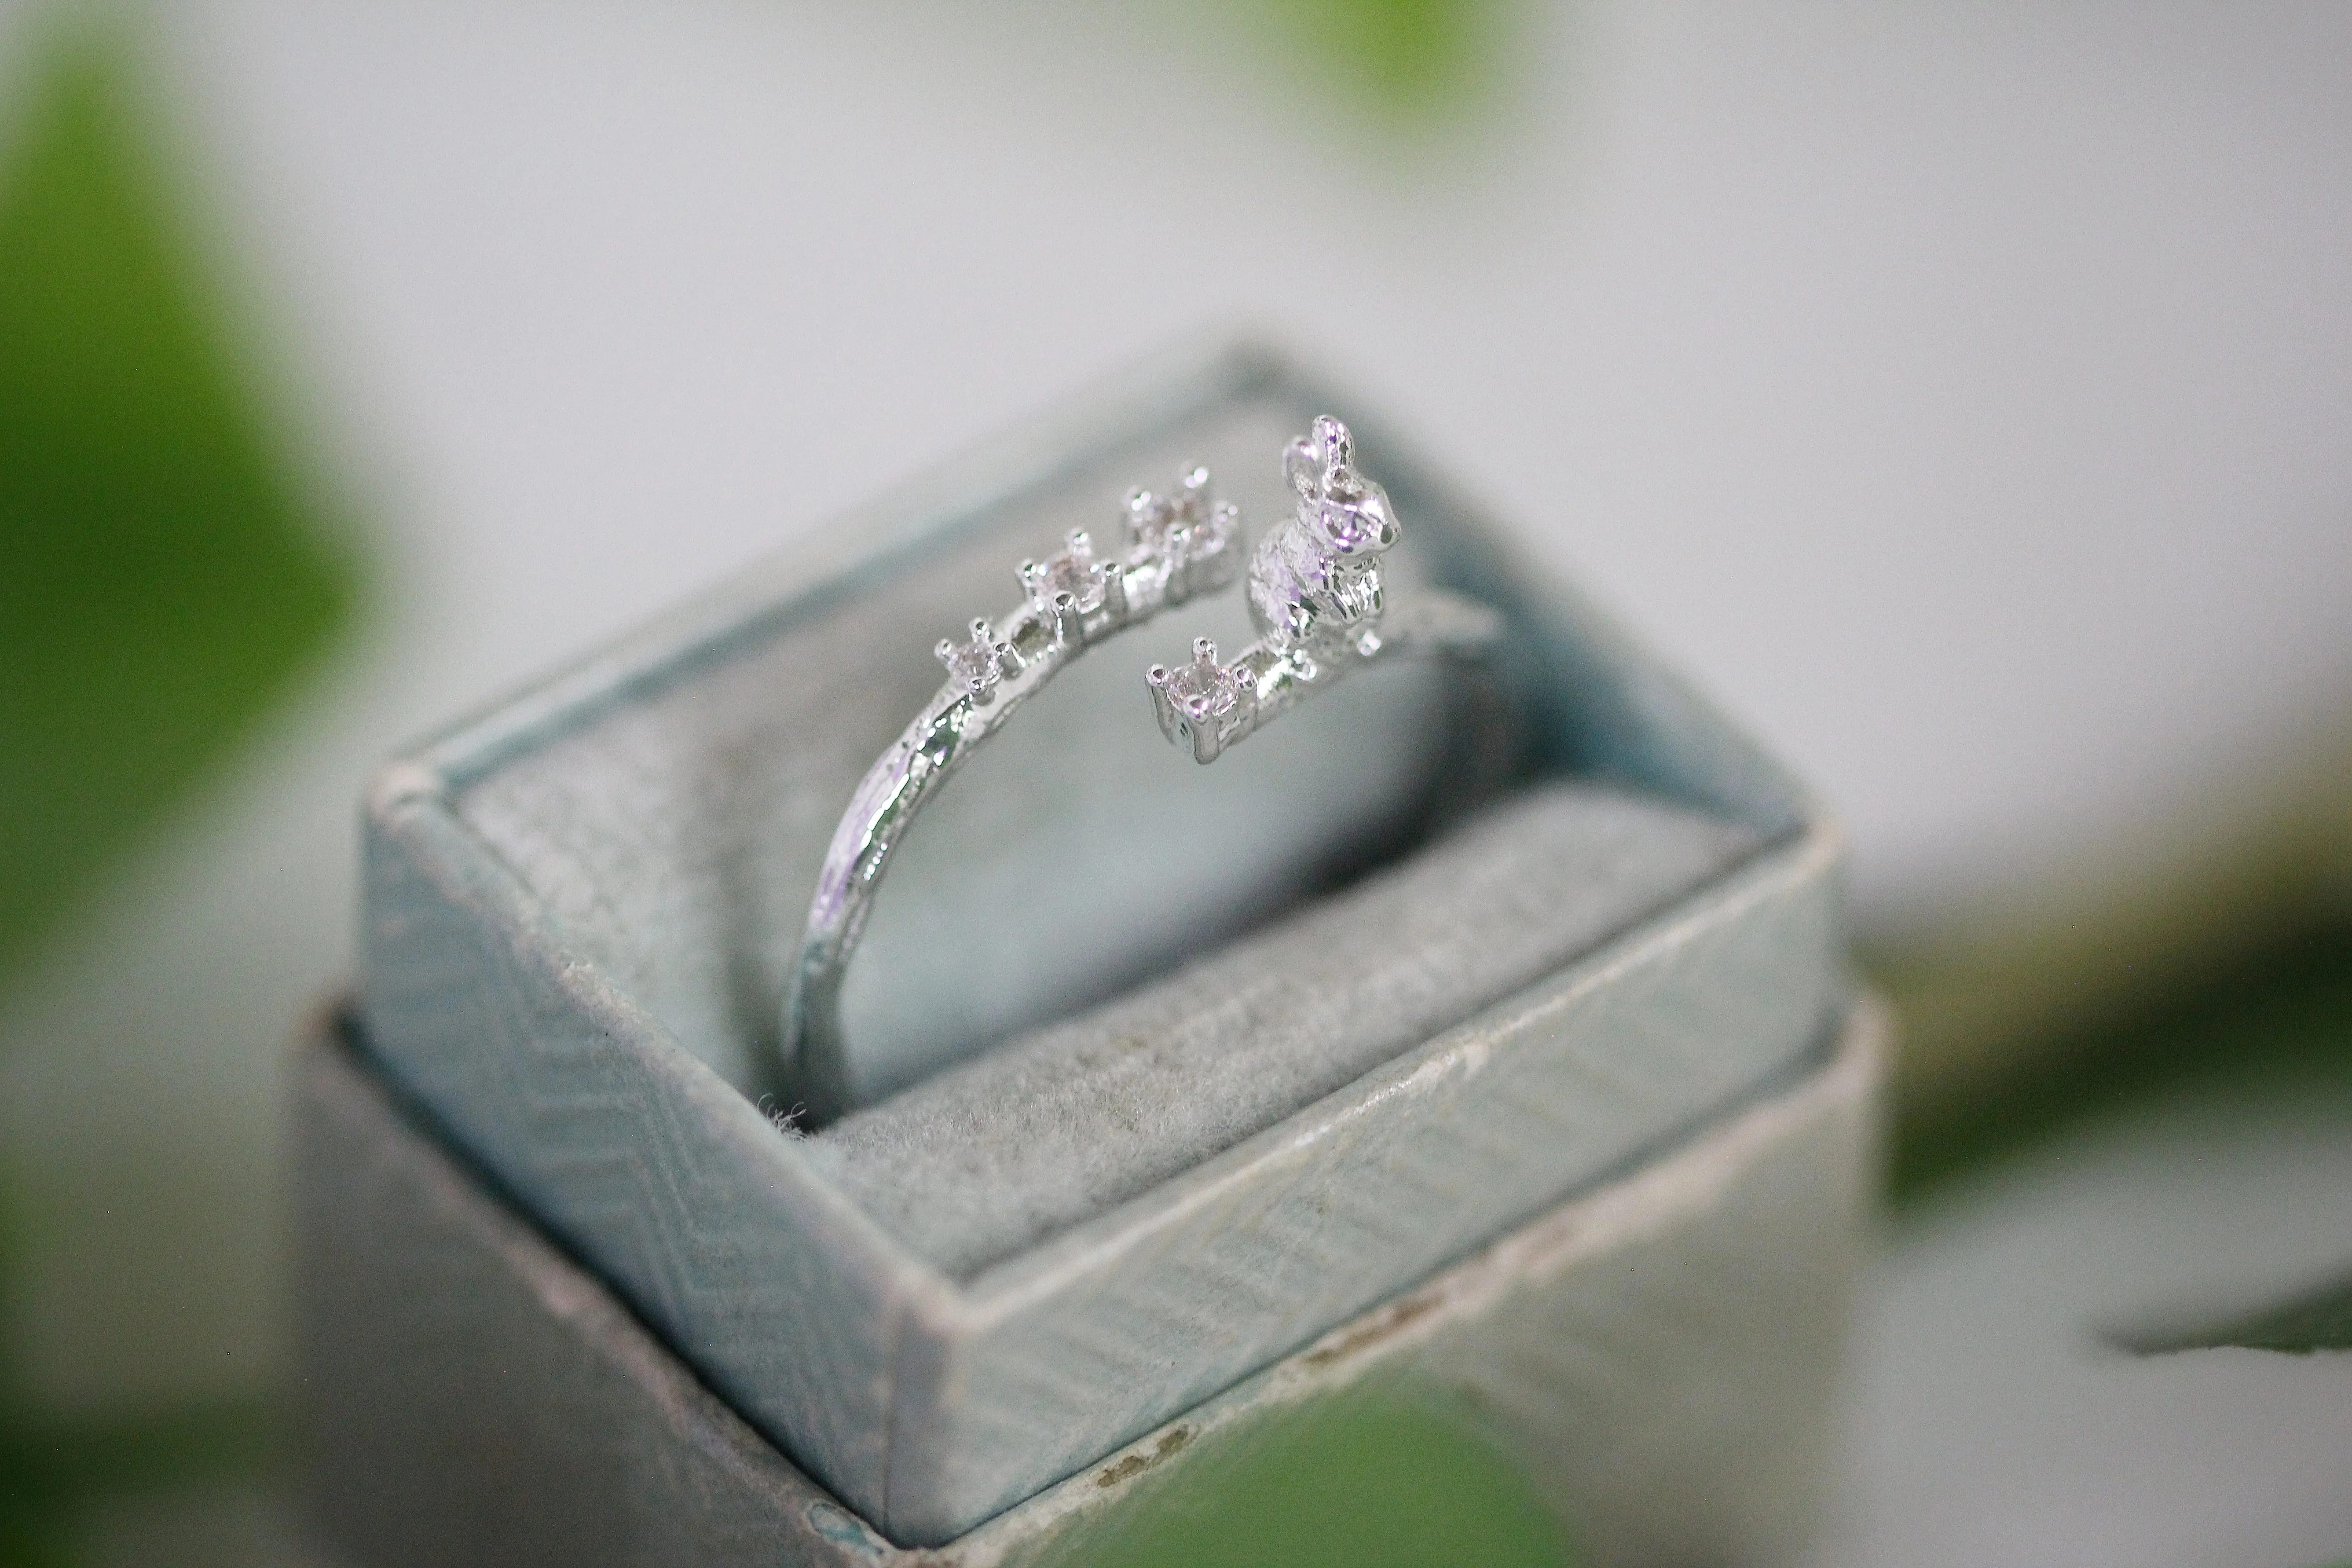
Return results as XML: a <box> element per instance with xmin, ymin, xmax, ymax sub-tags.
<box><xmin>294</xmin><ymin>1006</ymin><xmax>1884</xmax><ymax>1568</ymax></box>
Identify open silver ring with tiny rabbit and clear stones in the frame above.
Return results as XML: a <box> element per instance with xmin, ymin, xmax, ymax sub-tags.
<box><xmin>781</xmin><ymin>416</ymin><xmax>1500</xmax><ymax>1124</ymax></box>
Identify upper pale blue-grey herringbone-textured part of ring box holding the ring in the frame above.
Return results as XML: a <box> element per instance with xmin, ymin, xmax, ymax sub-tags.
<box><xmin>360</xmin><ymin>350</ymin><xmax>1851</xmax><ymax>1547</ymax></box>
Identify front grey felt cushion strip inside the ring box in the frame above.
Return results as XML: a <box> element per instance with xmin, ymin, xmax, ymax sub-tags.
<box><xmin>804</xmin><ymin>783</ymin><xmax>1762</xmax><ymax>1277</ymax></box>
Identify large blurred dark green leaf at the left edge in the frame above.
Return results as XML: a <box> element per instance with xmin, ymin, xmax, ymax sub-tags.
<box><xmin>0</xmin><ymin>21</ymin><xmax>353</xmax><ymax>969</ymax></box>
